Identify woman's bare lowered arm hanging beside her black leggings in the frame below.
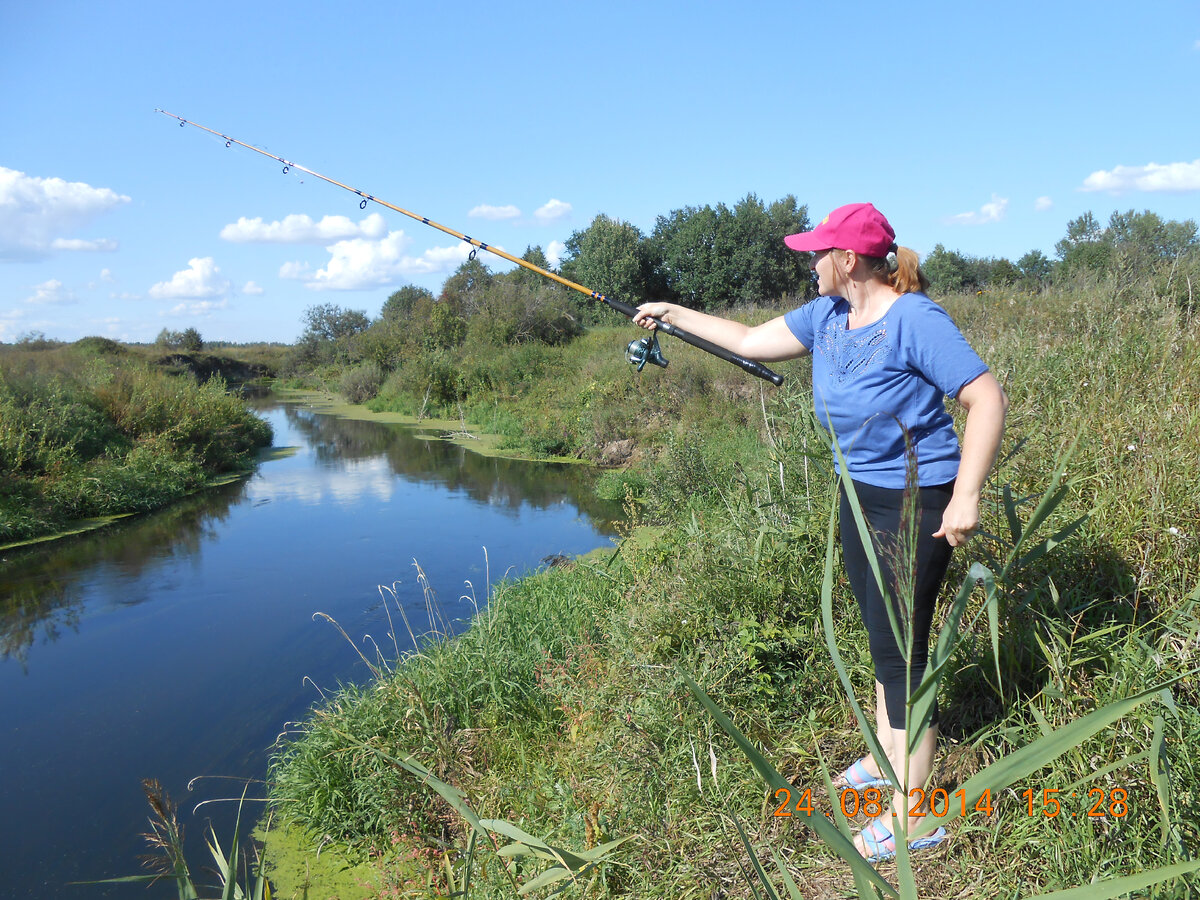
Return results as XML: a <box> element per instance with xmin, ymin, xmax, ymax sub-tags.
<box><xmin>934</xmin><ymin>372</ymin><xmax>1008</xmax><ymax>547</ymax></box>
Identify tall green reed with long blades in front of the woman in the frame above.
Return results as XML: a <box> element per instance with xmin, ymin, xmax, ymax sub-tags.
<box><xmin>683</xmin><ymin>434</ymin><xmax>1200</xmax><ymax>900</ymax></box>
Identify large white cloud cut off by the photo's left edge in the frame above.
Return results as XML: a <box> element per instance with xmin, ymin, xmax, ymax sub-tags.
<box><xmin>0</xmin><ymin>166</ymin><xmax>130</xmax><ymax>260</ymax></box>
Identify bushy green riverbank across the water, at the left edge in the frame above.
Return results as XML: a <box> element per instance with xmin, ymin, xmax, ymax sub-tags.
<box><xmin>0</xmin><ymin>338</ymin><xmax>271</xmax><ymax>550</ymax></box>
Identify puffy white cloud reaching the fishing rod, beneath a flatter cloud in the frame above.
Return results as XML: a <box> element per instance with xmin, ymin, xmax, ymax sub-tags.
<box><xmin>280</xmin><ymin>232</ymin><xmax>470</xmax><ymax>290</ymax></box>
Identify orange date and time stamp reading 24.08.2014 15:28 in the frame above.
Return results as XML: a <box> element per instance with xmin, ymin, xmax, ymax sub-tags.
<box><xmin>772</xmin><ymin>787</ymin><xmax>1129</xmax><ymax>818</ymax></box>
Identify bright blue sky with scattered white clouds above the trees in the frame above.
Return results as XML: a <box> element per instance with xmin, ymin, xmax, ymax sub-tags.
<box><xmin>0</xmin><ymin>0</ymin><xmax>1200</xmax><ymax>341</ymax></box>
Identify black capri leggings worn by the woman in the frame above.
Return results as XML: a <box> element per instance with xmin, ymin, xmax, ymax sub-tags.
<box><xmin>840</xmin><ymin>481</ymin><xmax>954</xmax><ymax>728</ymax></box>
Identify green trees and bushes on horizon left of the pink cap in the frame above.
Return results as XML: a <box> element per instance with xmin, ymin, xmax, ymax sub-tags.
<box><xmin>288</xmin><ymin>194</ymin><xmax>812</xmax><ymax>406</ymax></box>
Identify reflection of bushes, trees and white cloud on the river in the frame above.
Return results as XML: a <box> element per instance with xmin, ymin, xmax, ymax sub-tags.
<box><xmin>0</xmin><ymin>404</ymin><xmax>616</xmax><ymax>666</ymax></box>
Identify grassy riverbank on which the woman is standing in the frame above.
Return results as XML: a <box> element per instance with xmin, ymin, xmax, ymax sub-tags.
<box><xmin>271</xmin><ymin>280</ymin><xmax>1200</xmax><ymax>898</ymax></box>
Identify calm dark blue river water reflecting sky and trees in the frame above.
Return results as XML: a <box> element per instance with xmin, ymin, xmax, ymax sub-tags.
<box><xmin>0</xmin><ymin>404</ymin><xmax>618</xmax><ymax>900</ymax></box>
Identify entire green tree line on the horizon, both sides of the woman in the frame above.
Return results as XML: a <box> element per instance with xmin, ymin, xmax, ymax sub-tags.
<box><xmin>285</xmin><ymin>200</ymin><xmax>1200</xmax><ymax>406</ymax></box>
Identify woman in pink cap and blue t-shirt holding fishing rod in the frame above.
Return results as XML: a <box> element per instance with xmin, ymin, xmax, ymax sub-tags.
<box><xmin>634</xmin><ymin>203</ymin><xmax>1008</xmax><ymax>862</ymax></box>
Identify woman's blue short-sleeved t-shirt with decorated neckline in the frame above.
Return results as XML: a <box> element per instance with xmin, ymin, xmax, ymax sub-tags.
<box><xmin>784</xmin><ymin>294</ymin><xmax>988</xmax><ymax>488</ymax></box>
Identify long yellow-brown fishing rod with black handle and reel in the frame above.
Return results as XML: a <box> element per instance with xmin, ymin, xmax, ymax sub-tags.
<box><xmin>155</xmin><ymin>109</ymin><xmax>784</xmax><ymax>385</ymax></box>
